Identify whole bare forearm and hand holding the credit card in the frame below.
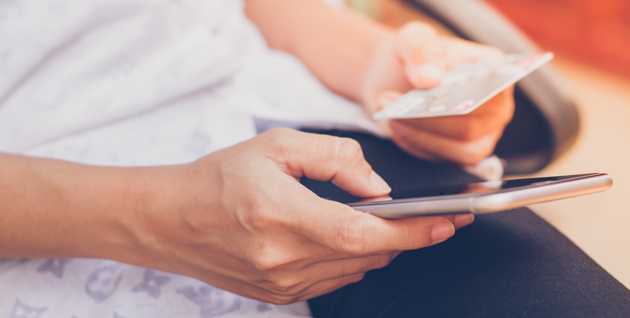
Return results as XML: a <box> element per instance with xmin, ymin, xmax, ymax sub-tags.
<box><xmin>245</xmin><ymin>0</ymin><xmax>514</xmax><ymax>165</ymax></box>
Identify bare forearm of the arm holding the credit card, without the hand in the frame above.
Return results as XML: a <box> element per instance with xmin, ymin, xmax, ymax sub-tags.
<box><xmin>246</xmin><ymin>0</ymin><xmax>392</xmax><ymax>102</ymax></box>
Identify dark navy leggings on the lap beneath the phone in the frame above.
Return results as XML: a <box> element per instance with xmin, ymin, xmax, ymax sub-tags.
<box><xmin>303</xmin><ymin>131</ymin><xmax>630</xmax><ymax>318</ymax></box>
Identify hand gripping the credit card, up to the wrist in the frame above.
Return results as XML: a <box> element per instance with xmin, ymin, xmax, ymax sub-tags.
<box><xmin>362</xmin><ymin>22</ymin><xmax>514</xmax><ymax>165</ymax></box>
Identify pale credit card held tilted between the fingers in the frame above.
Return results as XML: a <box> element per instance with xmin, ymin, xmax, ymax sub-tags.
<box><xmin>372</xmin><ymin>52</ymin><xmax>553</xmax><ymax>119</ymax></box>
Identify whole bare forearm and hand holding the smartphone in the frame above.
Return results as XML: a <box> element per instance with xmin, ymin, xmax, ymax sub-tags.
<box><xmin>0</xmin><ymin>129</ymin><xmax>472</xmax><ymax>304</ymax></box>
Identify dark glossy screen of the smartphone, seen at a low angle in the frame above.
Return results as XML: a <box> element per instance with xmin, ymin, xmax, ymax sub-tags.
<box><xmin>350</xmin><ymin>173</ymin><xmax>598</xmax><ymax>206</ymax></box>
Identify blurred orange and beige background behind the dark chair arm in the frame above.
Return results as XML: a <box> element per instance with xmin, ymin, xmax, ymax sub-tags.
<box><xmin>347</xmin><ymin>0</ymin><xmax>630</xmax><ymax>288</ymax></box>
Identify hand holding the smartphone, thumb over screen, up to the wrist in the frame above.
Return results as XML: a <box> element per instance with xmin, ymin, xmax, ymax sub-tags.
<box><xmin>120</xmin><ymin>129</ymin><xmax>472</xmax><ymax>304</ymax></box>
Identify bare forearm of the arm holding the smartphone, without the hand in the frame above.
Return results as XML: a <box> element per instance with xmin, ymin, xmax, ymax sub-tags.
<box><xmin>0</xmin><ymin>154</ymin><xmax>168</xmax><ymax>257</ymax></box>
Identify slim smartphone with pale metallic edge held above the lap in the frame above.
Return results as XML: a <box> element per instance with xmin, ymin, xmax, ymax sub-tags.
<box><xmin>347</xmin><ymin>173</ymin><xmax>612</xmax><ymax>219</ymax></box>
